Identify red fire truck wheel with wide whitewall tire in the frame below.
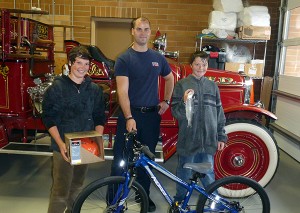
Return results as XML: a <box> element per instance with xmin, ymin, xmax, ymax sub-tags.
<box><xmin>215</xmin><ymin>120</ymin><xmax>279</xmax><ymax>187</ymax></box>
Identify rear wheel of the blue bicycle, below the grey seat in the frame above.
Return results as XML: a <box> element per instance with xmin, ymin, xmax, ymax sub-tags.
<box><xmin>197</xmin><ymin>176</ymin><xmax>270</xmax><ymax>213</ymax></box>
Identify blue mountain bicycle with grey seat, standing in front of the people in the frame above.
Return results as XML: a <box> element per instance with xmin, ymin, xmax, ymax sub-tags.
<box><xmin>73</xmin><ymin>132</ymin><xmax>270</xmax><ymax>213</ymax></box>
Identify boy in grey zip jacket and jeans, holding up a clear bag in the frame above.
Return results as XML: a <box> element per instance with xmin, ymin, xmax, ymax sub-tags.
<box><xmin>171</xmin><ymin>51</ymin><xmax>227</xmax><ymax>201</ymax></box>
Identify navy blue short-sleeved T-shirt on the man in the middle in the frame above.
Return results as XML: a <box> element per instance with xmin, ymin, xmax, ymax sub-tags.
<box><xmin>115</xmin><ymin>48</ymin><xmax>171</xmax><ymax>107</ymax></box>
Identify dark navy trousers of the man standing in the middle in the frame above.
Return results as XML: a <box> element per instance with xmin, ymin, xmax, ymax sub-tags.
<box><xmin>111</xmin><ymin>110</ymin><xmax>161</xmax><ymax>195</ymax></box>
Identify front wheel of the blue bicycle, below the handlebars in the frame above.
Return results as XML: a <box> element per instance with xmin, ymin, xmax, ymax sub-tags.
<box><xmin>72</xmin><ymin>176</ymin><xmax>148</xmax><ymax>213</ymax></box>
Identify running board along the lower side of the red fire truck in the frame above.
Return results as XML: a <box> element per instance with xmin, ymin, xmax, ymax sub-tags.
<box><xmin>0</xmin><ymin>142</ymin><xmax>164</xmax><ymax>162</ymax></box>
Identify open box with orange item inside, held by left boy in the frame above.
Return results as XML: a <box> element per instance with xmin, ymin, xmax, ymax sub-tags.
<box><xmin>65</xmin><ymin>131</ymin><xmax>104</xmax><ymax>165</ymax></box>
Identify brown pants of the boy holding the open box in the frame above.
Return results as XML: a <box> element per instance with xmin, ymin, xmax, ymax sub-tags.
<box><xmin>48</xmin><ymin>151</ymin><xmax>88</xmax><ymax>213</ymax></box>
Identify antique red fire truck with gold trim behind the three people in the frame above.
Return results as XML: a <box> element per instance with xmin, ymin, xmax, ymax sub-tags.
<box><xmin>0</xmin><ymin>9</ymin><xmax>279</xmax><ymax>189</ymax></box>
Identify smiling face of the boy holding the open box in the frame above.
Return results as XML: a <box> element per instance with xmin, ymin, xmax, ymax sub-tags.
<box><xmin>69</xmin><ymin>57</ymin><xmax>90</xmax><ymax>84</ymax></box>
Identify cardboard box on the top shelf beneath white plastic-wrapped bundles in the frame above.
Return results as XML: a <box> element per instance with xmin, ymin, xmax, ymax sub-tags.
<box><xmin>238</xmin><ymin>26</ymin><xmax>271</xmax><ymax>40</ymax></box>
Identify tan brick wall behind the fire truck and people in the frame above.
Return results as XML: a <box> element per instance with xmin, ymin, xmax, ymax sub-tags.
<box><xmin>0</xmin><ymin>0</ymin><xmax>280</xmax><ymax>76</ymax></box>
